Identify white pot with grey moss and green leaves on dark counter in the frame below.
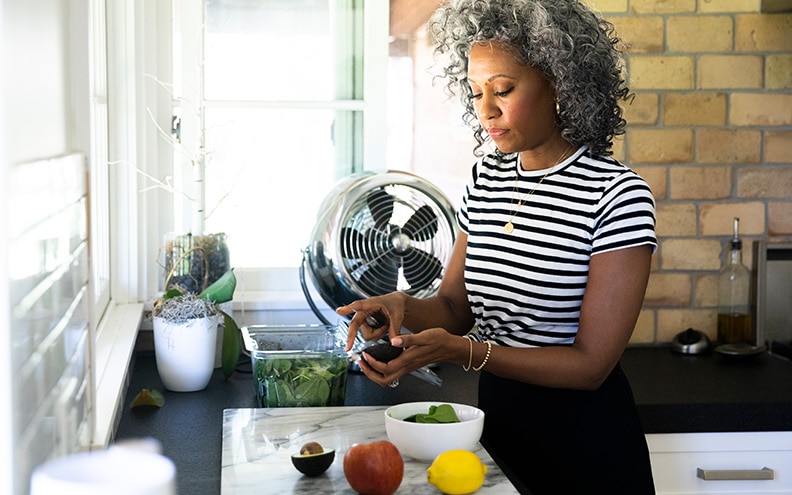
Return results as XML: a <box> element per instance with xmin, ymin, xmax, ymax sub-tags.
<box><xmin>152</xmin><ymin>269</ymin><xmax>241</xmax><ymax>392</ymax></box>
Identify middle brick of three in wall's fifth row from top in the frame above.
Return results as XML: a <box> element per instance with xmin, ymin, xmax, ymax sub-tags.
<box><xmin>696</xmin><ymin>129</ymin><xmax>762</xmax><ymax>163</ymax></box>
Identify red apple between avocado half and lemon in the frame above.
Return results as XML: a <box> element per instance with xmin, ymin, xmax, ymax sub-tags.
<box><xmin>344</xmin><ymin>440</ymin><xmax>404</xmax><ymax>495</ymax></box>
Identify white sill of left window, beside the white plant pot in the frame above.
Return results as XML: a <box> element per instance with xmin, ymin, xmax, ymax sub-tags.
<box><xmin>91</xmin><ymin>304</ymin><xmax>143</xmax><ymax>449</ymax></box>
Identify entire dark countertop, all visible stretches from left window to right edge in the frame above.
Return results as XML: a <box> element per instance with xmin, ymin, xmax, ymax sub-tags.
<box><xmin>116</xmin><ymin>347</ymin><xmax>792</xmax><ymax>495</ymax></box>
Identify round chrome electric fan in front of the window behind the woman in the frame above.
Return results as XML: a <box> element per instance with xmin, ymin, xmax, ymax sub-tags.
<box><xmin>300</xmin><ymin>171</ymin><xmax>456</xmax><ymax>325</ymax></box>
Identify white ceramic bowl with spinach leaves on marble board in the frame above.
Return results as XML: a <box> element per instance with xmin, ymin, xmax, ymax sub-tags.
<box><xmin>385</xmin><ymin>402</ymin><xmax>484</xmax><ymax>462</ymax></box>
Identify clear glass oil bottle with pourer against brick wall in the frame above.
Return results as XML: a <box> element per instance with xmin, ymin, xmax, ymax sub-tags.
<box><xmin>718</xmin><ymin>218</ymin><xmax>753</xmax><ymax>344</ymax></box>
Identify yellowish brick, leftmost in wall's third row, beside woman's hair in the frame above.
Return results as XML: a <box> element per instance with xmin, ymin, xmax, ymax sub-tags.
<box><xmin>630</xmin><ymin>55</ymin><xmax>694</xmax><ymax>90</ymax></box>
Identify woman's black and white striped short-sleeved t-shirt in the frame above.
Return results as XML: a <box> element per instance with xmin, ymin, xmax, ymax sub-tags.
<box><xmin>457</xmin><ymin>147</ymin><xmax>657</xmax><ymax>347</ymax></box>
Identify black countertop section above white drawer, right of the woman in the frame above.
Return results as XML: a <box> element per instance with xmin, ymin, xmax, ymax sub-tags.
<box><xmin>621</xmin><ymin>347</ymin><xmax>792</xmax><ymax>433</ymax></box>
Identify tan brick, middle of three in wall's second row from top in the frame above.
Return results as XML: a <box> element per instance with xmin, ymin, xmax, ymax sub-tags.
<box><xmin>666</xmin><ymin>14</ymin><xmax>734</xmax><ymax>53</ymax></box>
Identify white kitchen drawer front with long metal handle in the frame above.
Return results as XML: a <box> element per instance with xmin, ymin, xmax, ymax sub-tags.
<box><xmin>646</xmin><ymin>431</ymin><xmax>792</xmax><ymax>495</ymax></box>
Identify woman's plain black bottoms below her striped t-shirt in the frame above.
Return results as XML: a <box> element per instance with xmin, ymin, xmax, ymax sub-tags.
<box><xmin>478</xmin><ymin>365</ymin><xmax>655</xmax><ymax>495</ymax></box>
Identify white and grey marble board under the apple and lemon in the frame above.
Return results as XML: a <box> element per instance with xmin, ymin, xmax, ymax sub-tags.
<box><xmin>220</xmin><ymin>406</ymin><xmax>518</xmax><ymax>495</ymax></box>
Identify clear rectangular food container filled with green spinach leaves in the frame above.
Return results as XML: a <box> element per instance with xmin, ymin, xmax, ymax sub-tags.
<box><xmin>242</xmin><ymin>325</ymin><xmax>348</xmax><ymax>407</ymax></box>
